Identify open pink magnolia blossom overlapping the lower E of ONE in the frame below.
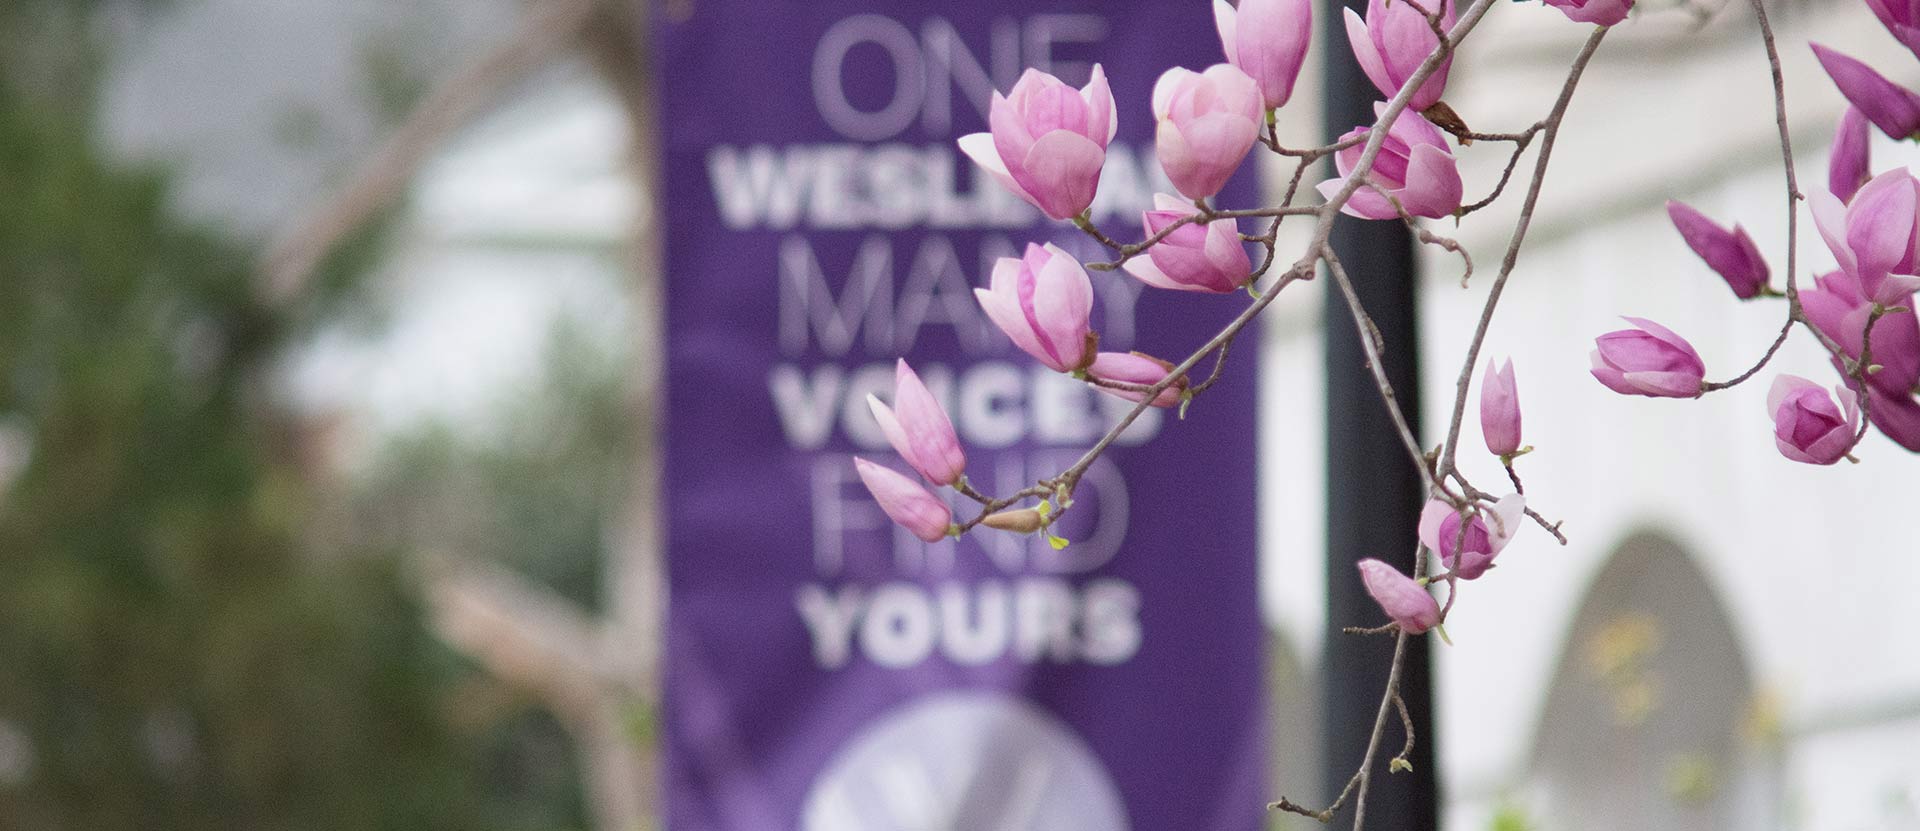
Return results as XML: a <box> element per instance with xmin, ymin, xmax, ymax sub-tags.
<box><xmin>960</xmin><ymin>63</ymin><xmax>1119</xmax><ymax>219</ymax></box>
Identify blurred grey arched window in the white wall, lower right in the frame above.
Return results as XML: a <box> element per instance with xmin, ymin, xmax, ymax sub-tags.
<box><xmin>1530</xmin><ymin>534</ymin><xmax>1780</xmax><ymax>831</ymax></box>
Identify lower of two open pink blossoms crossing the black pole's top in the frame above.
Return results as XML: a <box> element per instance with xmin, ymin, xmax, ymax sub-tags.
<box><xmin>1319</xmin><ymin>104</ymin><xmax>1463</xmax><ymax>219</ymax></box>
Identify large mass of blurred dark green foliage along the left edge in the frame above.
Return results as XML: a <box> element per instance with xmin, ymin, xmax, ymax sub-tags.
<box><xmin>0</xmin><ymin>0</ymin><xmax>584</xmax><ymax>831</ymax></box>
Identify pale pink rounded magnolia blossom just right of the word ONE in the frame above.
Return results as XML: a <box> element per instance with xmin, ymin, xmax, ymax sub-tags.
<box><xmin>1154</xmin><ymin>63</ymin><xmax>1263</xmax><ymax>200</ymax></box>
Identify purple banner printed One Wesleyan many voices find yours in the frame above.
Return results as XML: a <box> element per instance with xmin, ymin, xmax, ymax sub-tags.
<box><xmin>657</xmin><ymin>0</ymin><xmax>1269</xmax><ymax>831</ymax></box>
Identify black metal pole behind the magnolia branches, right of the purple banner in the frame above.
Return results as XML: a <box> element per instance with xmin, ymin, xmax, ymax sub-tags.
<box><xmin>1319</xmin><ymin>0</ymin><xmax>1440</xmax><ymax>831</ymax></box>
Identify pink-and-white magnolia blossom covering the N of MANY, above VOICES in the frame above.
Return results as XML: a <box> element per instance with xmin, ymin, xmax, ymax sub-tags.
<box><xmin>973</xmin><ymin>242</ymin><xmax>1098</xmax><ymax>372</ymax></box>
